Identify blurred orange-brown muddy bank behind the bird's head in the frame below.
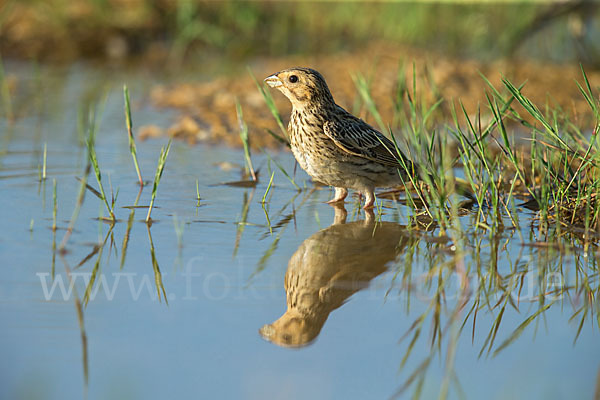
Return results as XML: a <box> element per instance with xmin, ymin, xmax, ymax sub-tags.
<box><xmin>145</xmin><ymin>44</ymin><xmax>600</xmax><ymax>148</ymax></box>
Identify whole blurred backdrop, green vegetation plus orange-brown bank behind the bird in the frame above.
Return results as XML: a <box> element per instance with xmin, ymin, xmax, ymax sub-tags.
<box><xmin>0</xmin><ymin>0</ymin><xmax>600</xmax><ymax>147</ymax></box>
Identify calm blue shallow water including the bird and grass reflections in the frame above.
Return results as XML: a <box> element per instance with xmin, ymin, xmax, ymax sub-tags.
<box><xmin>0</xmin><ymin>65</ymin><xmax>600</xmax><ymax>399</ymax></box>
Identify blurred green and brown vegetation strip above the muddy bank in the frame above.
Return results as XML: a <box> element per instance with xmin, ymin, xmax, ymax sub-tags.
<box><xmin>0</xmin><ymin>0</ymin><xmax>600</xmax><ymax>67</ymax></box>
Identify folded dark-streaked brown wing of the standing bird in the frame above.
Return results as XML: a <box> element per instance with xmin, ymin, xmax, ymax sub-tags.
<box><xmin>323</xmin><ymin>117</ymin><xmax>409</xmax><ymax>167</ymax></box>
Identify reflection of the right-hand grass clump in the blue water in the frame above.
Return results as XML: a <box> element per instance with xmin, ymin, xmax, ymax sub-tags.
<box><xmin>386</xmin><ymin>213</ymin><xmax>600</xmax><ymax>398</ymax></box>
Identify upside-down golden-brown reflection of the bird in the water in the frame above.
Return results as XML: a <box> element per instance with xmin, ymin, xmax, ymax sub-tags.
<box><xmin>259</xmin><ymin>206</ymin><xmax>410</xmax><ymax>347</ymax></box>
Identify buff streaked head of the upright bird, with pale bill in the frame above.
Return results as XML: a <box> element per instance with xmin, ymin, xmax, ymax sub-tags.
<box><xmin>265</xmin><ymin>67</ymin><xmax>333</xmax><ymax>108</ymax></box>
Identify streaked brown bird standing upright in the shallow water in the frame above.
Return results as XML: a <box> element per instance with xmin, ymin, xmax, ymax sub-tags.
<box><xmin>265</xmin><ymin>67</ymin><xmax>415</xmax><ymax>209</ymax></box>
